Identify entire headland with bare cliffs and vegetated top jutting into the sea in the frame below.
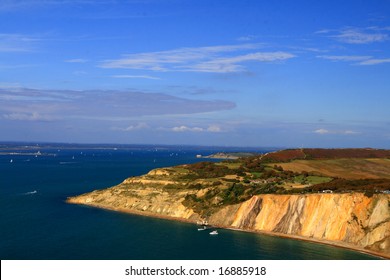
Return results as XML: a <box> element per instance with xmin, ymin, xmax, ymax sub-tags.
<box><xmin>67</xmin><ymin>149</ymin><xmax>390</xmax><ymax>259</ymax></box>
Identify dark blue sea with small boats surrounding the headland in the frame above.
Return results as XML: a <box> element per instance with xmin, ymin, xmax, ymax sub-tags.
<box><xmin>0</xmin><ymin>145</ymin><xmax>373</xmax><ymax>260</ymax></box>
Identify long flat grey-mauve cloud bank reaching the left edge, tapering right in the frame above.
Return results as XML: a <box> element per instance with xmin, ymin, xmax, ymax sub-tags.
<box><xmin>0</xmin><ymin>88</ymin><xmax>235</xmax><ymax>121</ymax></box>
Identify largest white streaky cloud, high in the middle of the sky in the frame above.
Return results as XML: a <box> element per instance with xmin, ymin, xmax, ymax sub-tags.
<box><xmin>100</xmin><ymin>44</ymin><xmax>294</xmax><ymax>73</ymax></box>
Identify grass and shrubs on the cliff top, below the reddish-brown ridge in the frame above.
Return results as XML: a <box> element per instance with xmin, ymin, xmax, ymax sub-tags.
<box><xmin>119</xmin><ymin>152</ymin><xmax>390</xmax><ymax>217</ymax></box>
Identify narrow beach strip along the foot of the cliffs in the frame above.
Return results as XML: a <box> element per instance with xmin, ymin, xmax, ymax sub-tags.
<box><xmin>65</xmin><ymin>198</ymin><xmax>390</xmax><ymax>260</ymax></box>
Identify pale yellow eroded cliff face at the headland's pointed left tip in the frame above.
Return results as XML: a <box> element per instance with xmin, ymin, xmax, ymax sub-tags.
<box><xmin>67</xmin><ymin>169</ymin><xmax>200</xmax><ymax>221</ymax></box>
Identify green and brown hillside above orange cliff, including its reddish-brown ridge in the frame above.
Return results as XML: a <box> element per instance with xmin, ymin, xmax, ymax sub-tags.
<box><xmin>168</xmin><ymin>149</ymin><xmax>390</xmax><ymax>216</ymax></box>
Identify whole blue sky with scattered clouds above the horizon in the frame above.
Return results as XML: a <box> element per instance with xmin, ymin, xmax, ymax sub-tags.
<box><xmin>0</xmin><ymin>0</ymin><xmax>390</xmax><ymax>148</ymax></box>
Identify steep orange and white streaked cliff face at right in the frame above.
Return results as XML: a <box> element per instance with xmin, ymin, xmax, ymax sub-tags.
<box><xmin>215</xmin><ymin>193</ymin><xmax>390</xmax><ymax>257</ymax></box>
